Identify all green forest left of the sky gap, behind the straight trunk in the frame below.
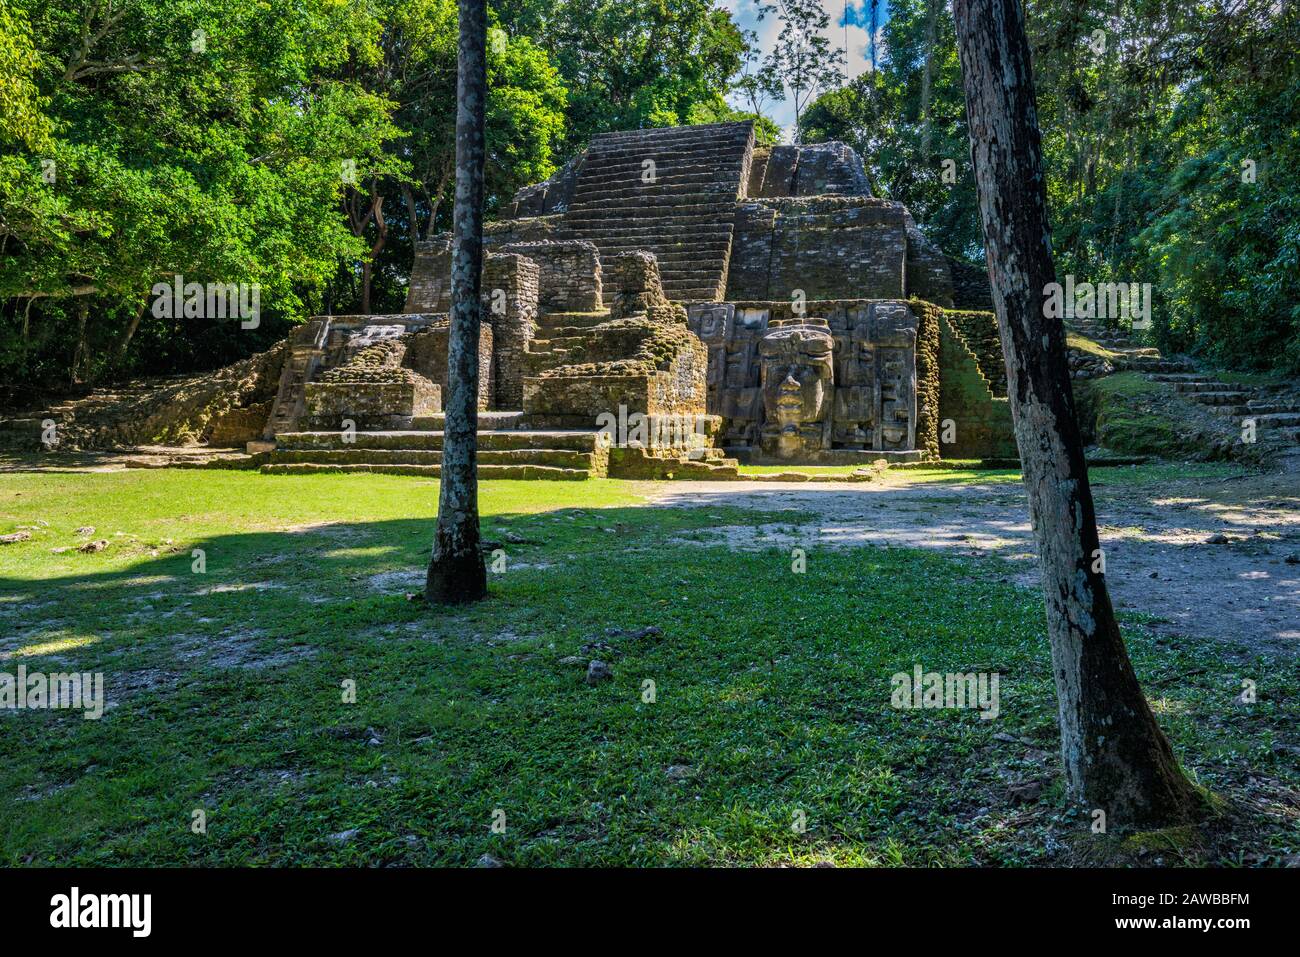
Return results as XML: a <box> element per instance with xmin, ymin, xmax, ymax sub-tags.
<box><xmin>0</xmin><ymin>0</ymin><xmax>779</xmax><ymax>395</ymax></box>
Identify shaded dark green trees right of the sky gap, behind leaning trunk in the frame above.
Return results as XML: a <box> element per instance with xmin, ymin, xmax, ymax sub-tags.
<box><xmin>803</xmin><ymin>0</ymin><xmax>1300</xmax><ymax>369</ymax></box>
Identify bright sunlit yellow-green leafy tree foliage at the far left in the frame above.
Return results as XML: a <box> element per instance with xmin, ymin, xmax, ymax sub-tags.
<box><xmin>0</xmin><ymin>0</ymin><xmax>397</xmax><ymax>378</ymax></box>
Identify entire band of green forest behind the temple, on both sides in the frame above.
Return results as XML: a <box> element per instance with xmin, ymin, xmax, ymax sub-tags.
<box><xmin>0</xmin><ymin>0</ymin><xmax>1300</xmax><ymax>394</ymax></box>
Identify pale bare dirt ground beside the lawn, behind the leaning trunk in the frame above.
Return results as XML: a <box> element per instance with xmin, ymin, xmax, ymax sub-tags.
<box><xmin>646</xmin><ymin>471</ymin><xmax>1300</xmax><ymax>651</ymax></box>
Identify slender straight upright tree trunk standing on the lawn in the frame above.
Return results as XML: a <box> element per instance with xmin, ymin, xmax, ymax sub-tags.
<box><xmin>424</xmin><ymin>0</ymin><xmax>488</xmax><ymax>605</ymax></box>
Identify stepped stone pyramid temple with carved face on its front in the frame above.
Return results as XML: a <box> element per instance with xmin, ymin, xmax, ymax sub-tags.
<box><xmin>248</xmin><ymin>122</ymin><xmax>1015</xmax><ymax>479</ymax></box>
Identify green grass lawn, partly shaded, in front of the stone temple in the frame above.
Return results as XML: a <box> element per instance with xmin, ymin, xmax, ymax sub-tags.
<box><xmin>0</xmin><ymin>471</ymin><xmax>1300</xmax><ymax>865</ymax></box>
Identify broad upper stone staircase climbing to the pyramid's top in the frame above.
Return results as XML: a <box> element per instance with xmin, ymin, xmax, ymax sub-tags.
<box><xmin>562</xmin><ymin>122</ymin><xmax>754</xmax><ymax>302</ymax></box>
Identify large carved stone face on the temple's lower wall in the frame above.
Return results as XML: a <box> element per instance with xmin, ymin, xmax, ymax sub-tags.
<box><xmin>759</xmin><ymin>324</ymin><xmax>835</xmax><ymax>459</ymax></box>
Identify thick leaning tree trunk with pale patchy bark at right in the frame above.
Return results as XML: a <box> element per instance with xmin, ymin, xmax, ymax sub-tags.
<box><xmin>953</xmin><ymin>0</ymin><xmax>1197</xmax><ymax>831</ymax></box>
